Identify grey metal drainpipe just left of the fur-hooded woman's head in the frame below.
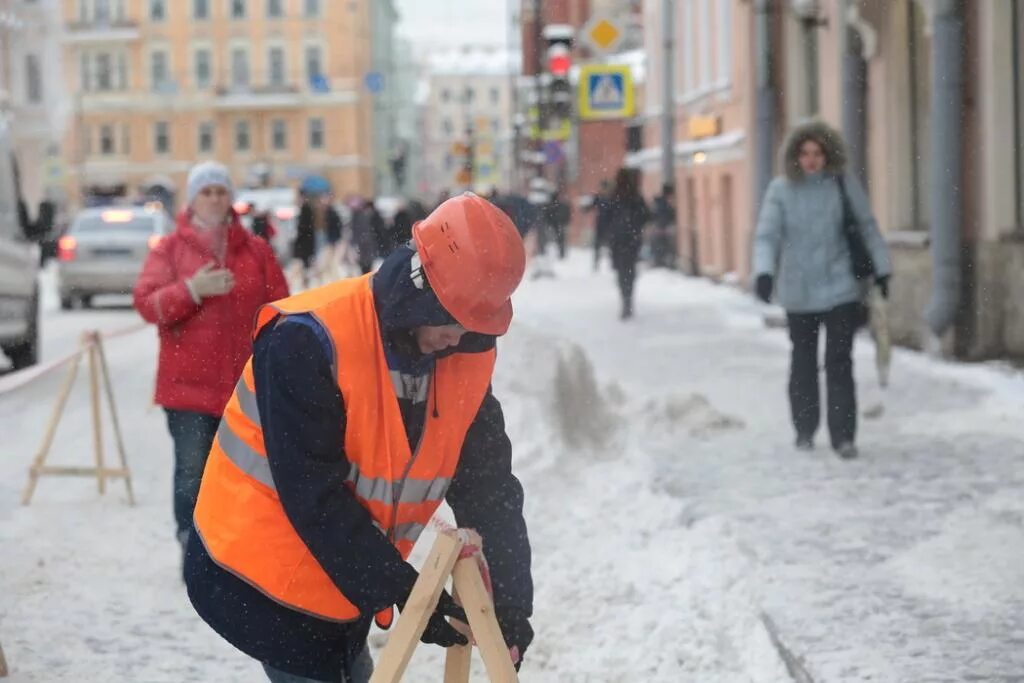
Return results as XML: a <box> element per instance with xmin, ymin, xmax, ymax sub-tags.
<box><xmin>753</xmin><ymin>0</ymin><xmax>775</xmax><ymax>219</ymax></box>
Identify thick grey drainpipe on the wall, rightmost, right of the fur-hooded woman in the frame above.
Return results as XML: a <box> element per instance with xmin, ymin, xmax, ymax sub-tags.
<box><xmin>925</xmin><ymin>0</ymin><xmax>965</xmax><ymax>337</ymax></box>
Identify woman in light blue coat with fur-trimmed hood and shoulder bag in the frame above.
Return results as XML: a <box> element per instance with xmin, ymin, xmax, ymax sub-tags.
<box><xmin>754</xmin><ymin>122</ymin><xmax>892</xmax><ymax>458</ymax></box>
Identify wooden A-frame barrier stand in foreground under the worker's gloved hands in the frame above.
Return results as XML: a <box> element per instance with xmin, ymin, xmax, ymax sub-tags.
<box><xmin>370</xmin><ymin>530</ymin><xmax>519</xmax><ymax>683</ymax></box>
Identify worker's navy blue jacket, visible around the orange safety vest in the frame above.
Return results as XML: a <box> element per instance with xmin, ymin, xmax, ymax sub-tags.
<box><xmin>185</xmin><ymin>247</ymin><xmax>534</xmax><ymax>680</ymax></box>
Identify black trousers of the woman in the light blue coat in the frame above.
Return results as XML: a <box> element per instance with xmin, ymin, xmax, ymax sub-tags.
<box><xmin>788</xmin><ymin>303</ymin><xmax>860</xmax><ymax>447</ymax></box>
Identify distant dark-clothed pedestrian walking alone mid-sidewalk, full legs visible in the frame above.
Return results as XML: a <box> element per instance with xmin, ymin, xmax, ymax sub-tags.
<box><xmin>608</xmin><ymin>168</ymin><xmax>650</xmax><ymax>321</ymax></box>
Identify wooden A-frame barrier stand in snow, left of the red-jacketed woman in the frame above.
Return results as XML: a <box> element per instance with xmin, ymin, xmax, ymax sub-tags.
<box><xmin>19</xmin><ymin>331</ymin><xmax>135</xmax><ymax>507</ymax></box>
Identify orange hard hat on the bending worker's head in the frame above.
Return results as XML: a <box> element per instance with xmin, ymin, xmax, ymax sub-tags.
<box><xmin>413</xmin><ymin>193</ymin><xmax>526</xmax><ymax>336</ymax></box>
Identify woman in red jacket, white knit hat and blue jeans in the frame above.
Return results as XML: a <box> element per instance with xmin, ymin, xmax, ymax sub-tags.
<box><xmin>134</xmin><ymin>162</ymin><xmax>288</xmax><ymax>573</ymax></box>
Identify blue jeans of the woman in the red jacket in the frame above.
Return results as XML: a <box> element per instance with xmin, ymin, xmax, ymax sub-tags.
<box><xmin>164</xmin><ymin>408</ymin><xmax>220</xmax><ymax>548</ymax></box>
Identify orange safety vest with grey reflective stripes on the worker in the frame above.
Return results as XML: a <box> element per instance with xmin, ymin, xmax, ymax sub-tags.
<box><xmin>195</xmin><ymin>275</ymin><xmax>496</xmax><ymax>623</ymax></box>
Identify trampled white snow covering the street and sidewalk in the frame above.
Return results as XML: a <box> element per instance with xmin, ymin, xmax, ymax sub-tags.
<box><xmin>0</xmin><ymin>254</ymin><xmax>1024</xmax><ymax>683</ymax></box>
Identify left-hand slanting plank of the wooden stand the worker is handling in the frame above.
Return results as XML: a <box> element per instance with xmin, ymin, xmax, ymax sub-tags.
<box><xmin>370</xmin><ymin>533</ymin><xmax>462</xmax><ymax>683</ymax></box>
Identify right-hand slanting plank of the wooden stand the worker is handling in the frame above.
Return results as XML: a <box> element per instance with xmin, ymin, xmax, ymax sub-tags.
<box><xmin>452</xmin><ymin>557</ymin><xmax>519</xmax><ymax>683</ymax></box>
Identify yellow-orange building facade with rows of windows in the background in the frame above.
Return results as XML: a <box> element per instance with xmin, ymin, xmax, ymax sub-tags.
<box><xmin>63</xmin><ymin>0</ymin><xmax>373</xmax><ymax>204</ymax></box>
